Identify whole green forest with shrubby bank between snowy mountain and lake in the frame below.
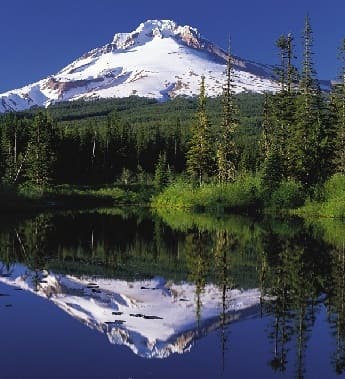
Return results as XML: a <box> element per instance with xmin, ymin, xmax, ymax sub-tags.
<box><xmin>0</xmin><ymin>18</ymin><xmax>345</xmax><ymax>217</ymax></box>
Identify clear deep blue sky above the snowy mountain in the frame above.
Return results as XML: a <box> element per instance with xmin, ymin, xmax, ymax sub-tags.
<box><xmin>0</xmin><ymin>0</ymin><xmax>345</xmax><ymax>92</ymax></box>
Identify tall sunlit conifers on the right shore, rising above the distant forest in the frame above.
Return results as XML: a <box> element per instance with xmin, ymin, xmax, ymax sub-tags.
<box><xmin>187</xmin><ymin>17</ymin><xmax>345</xmax><ymax>196</ymax></box>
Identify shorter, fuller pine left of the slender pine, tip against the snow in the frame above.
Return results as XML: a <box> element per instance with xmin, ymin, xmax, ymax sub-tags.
<box><xmin>187</xmin><ymin>76</ymin><xmax>214</xmax><ymax>185</ymax></box>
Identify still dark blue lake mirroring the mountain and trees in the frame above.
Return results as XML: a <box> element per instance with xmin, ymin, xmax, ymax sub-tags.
<box><xmin>0</xmin><ymin>209</ymin><xmax>345</xmax><ymax>379</ymax></box>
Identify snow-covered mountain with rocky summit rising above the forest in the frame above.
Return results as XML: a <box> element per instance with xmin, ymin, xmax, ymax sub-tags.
<box><xmin>0</xmin><ymin>20</ymin><xmax>277</xmax><ymax>112</ymax></box>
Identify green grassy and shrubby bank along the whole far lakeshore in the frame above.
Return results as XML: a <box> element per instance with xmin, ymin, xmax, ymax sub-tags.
<box><xmin>0</xmin><ymin>174</ymin><xmax>345</xmax><ymax>219</ymax></box>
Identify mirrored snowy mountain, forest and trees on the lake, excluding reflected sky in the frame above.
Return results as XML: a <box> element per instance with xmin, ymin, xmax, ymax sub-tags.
<box><xmin>0</xmin><ymin>210</ymin><xmax>345</xmax><ymax>378</ymax></box>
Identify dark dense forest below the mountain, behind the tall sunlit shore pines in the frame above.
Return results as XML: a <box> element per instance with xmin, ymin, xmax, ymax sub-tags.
<box><xmin>0</xmin><ymin>94</ymin><xmax>263</xmax><ymax>186</ymax></box>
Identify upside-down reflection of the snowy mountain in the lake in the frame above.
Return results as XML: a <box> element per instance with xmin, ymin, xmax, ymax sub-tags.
<box><xmin>0</xmin><ymin>264</ymin><xmax>260</xmax><ymax>358</ymax></box>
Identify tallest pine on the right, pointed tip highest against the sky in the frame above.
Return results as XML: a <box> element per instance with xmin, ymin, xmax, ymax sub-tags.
<box><xmin>289</xmin><ymin>17</ymin><xmax>333</xmax><ymax>188</ymax></box>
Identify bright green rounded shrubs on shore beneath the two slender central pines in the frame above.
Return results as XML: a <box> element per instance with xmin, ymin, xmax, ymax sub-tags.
<box><xmin>151</xmin><ymin>174</ymin><xmax>304</xmax><ymax>214</ymax></box>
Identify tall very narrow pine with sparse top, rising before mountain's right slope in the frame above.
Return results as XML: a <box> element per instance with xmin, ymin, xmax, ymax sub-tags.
<box><xmin>217</xmin><ymin>43</ymin><xmax>238</xmax><ymax>183</ymax></box>
